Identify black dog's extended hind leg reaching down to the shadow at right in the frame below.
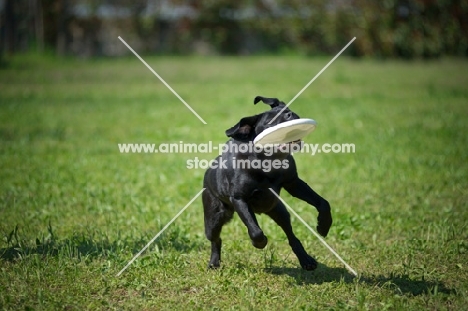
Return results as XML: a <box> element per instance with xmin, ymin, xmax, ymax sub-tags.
<box><xmin>266</xmin><ymin>202</ymin><xmax>317</xmax><ymax>270</ymax></box>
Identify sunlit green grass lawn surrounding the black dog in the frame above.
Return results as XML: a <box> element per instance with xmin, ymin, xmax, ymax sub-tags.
<box><xmin>0</xmin><ymin>56</ymin><xmax>468</xmax><ymax>310</ymax></box>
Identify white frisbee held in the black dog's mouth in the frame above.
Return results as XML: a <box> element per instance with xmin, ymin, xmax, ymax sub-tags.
<box><xmin>254</xmin><ymin>119</ymin><xmax>317</xmax><ymax>145</ymax></box>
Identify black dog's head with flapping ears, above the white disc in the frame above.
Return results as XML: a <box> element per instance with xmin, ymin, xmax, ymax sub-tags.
<box><xmin>226</xmin><ymin>96</ymin><xmax>299</xmax><ymax>142</ymax></box>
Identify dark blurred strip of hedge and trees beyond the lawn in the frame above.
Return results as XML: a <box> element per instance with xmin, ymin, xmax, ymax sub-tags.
<box><xmin>0</xmin><ymin>0</ymin><xmax>468</xmax><ymax>60</ymax></box>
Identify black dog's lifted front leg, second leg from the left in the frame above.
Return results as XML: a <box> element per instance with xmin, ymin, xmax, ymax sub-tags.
<box><xmin>231</xmin><ymin>197</ymin><xmax>268</xmax><ymax>249</ymax></box>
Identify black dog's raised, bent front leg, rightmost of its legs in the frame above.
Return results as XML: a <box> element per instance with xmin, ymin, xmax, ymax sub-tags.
<box><xmin>283</xmin><ymin>178</ymin><xmax>333</xmax><ymax>237</ymax></box>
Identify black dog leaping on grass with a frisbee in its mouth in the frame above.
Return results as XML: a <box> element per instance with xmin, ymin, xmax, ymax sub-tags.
<box><xmin>203</xmin><ymin>96</ymin><xmax>332</xmax><ymax>270</ymax></box>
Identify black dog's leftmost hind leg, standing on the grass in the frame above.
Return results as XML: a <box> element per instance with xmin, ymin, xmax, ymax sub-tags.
<box><xmin>202</xmin><ymin>189</ymin><xmax>234</xmax><ymax>268</ymax></box>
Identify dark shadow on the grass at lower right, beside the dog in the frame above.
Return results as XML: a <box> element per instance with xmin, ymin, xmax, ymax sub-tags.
<box><xmin>265</xmin><ymin>264</ymin><xmax>457</xmax><ymax>296</ymax></box>
